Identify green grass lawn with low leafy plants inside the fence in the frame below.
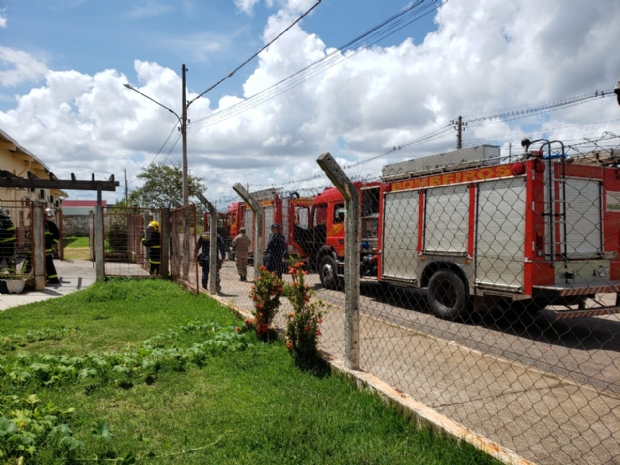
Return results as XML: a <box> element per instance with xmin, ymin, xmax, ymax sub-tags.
<box><xmin>0</xmin><ymin>280</ymin><xmax>498</xmax><ymax>465</ymax></box>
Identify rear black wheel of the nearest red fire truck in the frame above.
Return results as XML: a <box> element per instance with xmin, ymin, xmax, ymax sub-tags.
<box><xmin>428</xmin><ymin>270</ymin><xmax>468</xmax><ymax>320</ymax></box>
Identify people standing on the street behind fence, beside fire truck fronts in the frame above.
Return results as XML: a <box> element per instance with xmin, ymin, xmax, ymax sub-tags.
<box><xmin>196</xmin><ymin>223</ymin><xmax>288</xmax><ymax>292</ymax></box>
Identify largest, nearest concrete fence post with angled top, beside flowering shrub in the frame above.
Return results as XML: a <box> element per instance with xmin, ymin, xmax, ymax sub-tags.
<box><xmin>316</xmin><ymin>152</ymin><xmax>360</xmax><ymax>370</ymax></box>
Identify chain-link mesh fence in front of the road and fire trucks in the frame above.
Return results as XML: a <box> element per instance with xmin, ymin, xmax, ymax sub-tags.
<box><xmin>197</xmin><ymin>141</ymin><xmax>620</xmax><ymax>464</ymax></box>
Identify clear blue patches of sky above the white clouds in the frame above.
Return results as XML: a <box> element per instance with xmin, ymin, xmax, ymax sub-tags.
<box><xmin>0</xmin><ymin>0</ymin><xmax>436</xmax><ymax>110</ymax></box>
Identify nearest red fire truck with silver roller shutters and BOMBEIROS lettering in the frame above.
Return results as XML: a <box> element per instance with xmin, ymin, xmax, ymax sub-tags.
<box><xmin>304</xmin><ymin>146</ymin><xmax>620</xmax><ymax>319</ymax></box>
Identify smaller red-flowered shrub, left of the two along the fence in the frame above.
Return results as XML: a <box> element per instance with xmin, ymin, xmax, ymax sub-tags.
<box><xmin>245</xmin><ymin>266</ymin><xmax>284</xmax><ymax>340</ymax></box>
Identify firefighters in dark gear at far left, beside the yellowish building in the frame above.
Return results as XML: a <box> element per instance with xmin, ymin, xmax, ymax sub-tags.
<box><xmin>0</xmin><ymin>207</ymin><xmax>60</xmax><ymax>284</ymax></box>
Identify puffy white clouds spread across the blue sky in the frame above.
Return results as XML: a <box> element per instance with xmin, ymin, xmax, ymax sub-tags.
<box><xmin>0</xmin><ymin>0</ymin><xmax>620</xmax><ymax>203</ymax></box>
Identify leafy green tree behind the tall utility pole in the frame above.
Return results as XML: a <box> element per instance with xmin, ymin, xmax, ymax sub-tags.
<box><xmin>126</xmin><ymin>163</ymin><xmax>205</xmax><ymax>208</ymax></box>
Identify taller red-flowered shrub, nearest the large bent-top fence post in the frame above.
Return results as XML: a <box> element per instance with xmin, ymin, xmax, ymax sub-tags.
<box><xmin>284</xmin><ymin>257</ymin><xmax>329</xmax><ymax>368</ymax></box>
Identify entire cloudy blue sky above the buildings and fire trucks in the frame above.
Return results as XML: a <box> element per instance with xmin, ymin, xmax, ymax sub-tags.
<box><xmin>0</xmin><ymin>0</ymin><xmax>620</xmax><ymax>208</ymax></box>
